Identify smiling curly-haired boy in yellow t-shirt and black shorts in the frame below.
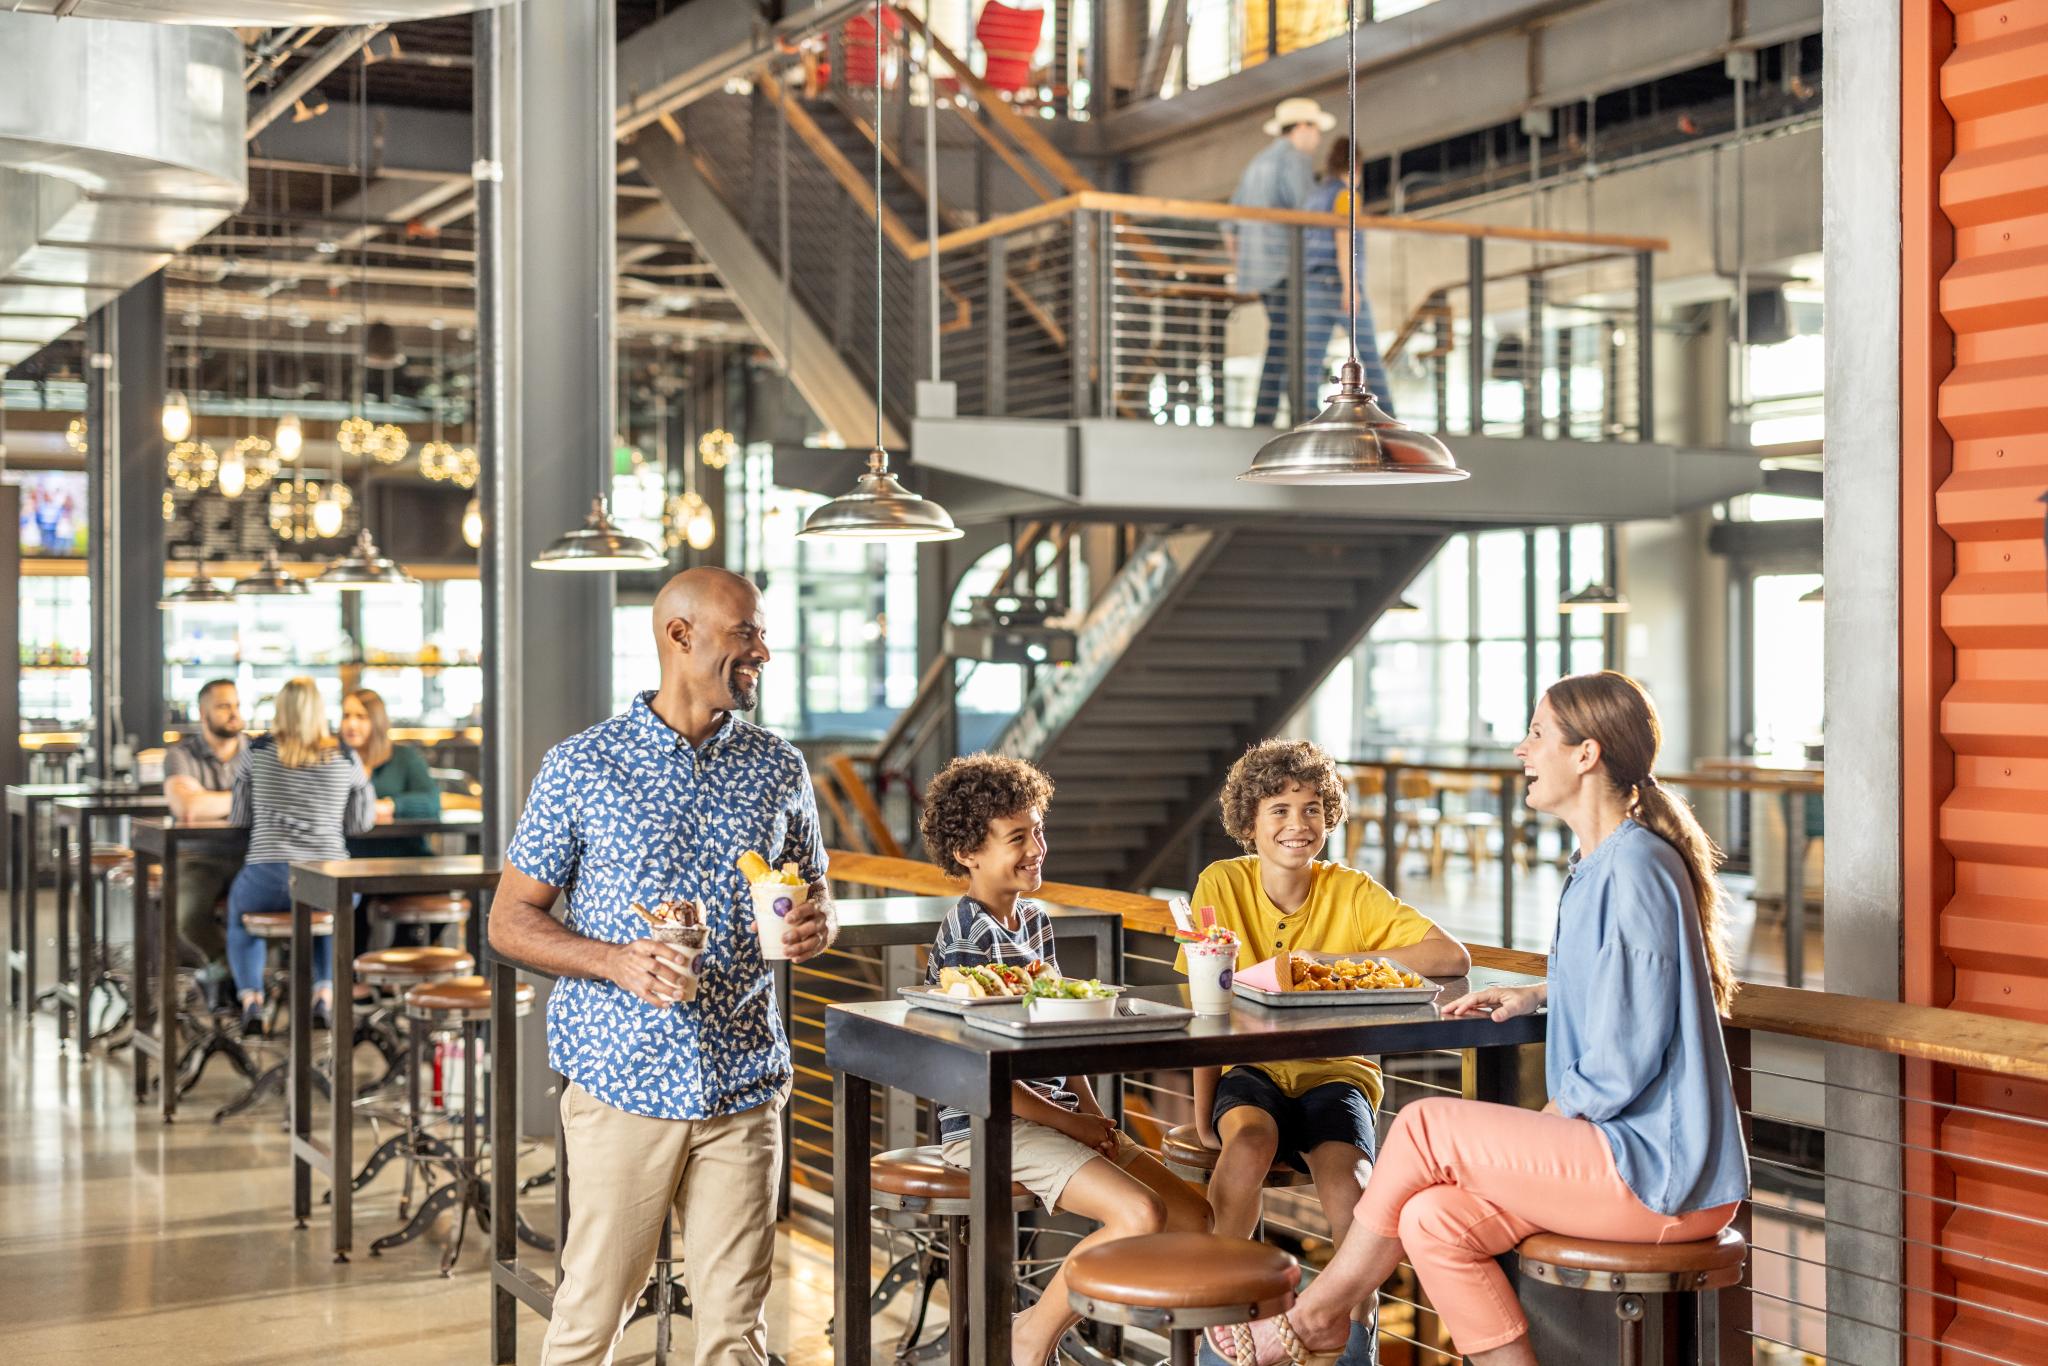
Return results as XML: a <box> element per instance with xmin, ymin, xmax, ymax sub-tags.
<box><xmin>1178</xmin><ymin>739</ymin><xmax>1473</xmax><ymax>1366</ymax></box>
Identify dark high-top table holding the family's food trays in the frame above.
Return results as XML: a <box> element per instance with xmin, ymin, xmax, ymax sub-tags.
<box><xmin>825</xmin><ymin>969</ymin><xmax>1540</xmax><ymax>1366</ymax></box>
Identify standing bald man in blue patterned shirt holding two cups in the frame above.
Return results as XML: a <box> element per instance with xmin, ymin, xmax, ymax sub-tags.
<box><xmin>489</xmin><ymin>567</ymin><xmax>836</xmax><ymax>1366</ymax></box>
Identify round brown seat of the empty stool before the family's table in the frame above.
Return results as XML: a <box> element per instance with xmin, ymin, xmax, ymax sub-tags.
<box><xmin>1067</xmin><ymin>1233</ymin><xmax>1300</xmax><ymax>1317</ymax></box>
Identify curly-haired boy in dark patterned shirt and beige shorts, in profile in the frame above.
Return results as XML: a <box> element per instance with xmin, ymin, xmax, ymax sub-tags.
<box><xmin>920</xmin><ymin>754</ymin><xmax>1208</xmax><ymax>1362</ymax></box>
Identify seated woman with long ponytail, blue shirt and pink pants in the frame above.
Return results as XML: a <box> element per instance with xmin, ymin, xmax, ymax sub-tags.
<box><xmin>1212</xmin><ymin>672</ymin><xmax>1749</xmax><ymax>1366</ymax></box>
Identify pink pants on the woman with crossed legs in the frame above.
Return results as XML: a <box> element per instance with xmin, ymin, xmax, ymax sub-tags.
<box><xmin>1358</xmin><ymin>1096</ymin><xmax>1737</xmax><ymax>1356</ymax></box>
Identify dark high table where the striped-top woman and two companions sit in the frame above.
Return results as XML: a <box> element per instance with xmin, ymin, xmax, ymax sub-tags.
<box><xmin>129</xmin><ymin>811</ymin><xmax>483</xmax><ymax>1124</ymax></box>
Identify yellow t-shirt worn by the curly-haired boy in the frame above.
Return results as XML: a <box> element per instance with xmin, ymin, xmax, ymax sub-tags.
<box><xmin>1174</xmin><ymin>854</ymin><xmax>1436</xmax><ymax>1108</ymax></box>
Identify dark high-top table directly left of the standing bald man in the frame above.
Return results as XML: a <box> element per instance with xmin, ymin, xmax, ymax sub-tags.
<box><xmin>289</xmin><ymin>854</ymin><xmax>501</xmax><ymax>1262</ymax></box>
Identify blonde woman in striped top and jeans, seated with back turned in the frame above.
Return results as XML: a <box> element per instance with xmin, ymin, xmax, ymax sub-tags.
<box><xmin>227</xmin><ymin>678</ymin><xmax>377</xmax><ymax>1036</ymax></box>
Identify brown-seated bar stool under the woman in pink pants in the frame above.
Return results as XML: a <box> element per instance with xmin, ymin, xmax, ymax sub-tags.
<box><xmin>1516</xmin><ymin>1229</ymin><xmax>1749</xmax><ymax>1366</ymax></box>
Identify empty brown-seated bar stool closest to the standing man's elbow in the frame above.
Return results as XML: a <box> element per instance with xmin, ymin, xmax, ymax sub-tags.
<box><xmin>371</xmin><ymin>970</ymin><xmax>555</xmax><ymax>1276</ymax></box>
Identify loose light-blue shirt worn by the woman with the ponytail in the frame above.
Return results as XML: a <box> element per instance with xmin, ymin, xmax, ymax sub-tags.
<box><xmin>1544</xmin><ymin>821</ymin><xmax>1749</xmax><ymax>1214</ymax></box>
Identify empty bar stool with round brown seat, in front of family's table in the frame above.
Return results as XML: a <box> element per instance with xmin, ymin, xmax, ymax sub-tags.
<box><xmin>1067</xmin><ymin>1233</ymin><xmax>1298</xmax><ymax>1366</ymax></box>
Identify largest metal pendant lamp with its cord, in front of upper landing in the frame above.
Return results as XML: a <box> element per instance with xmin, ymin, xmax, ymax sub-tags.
<box><xmin>1237</xmin><ymin>0</ymin><xmax>1479</xmax><ymax>483</ymax></box>
